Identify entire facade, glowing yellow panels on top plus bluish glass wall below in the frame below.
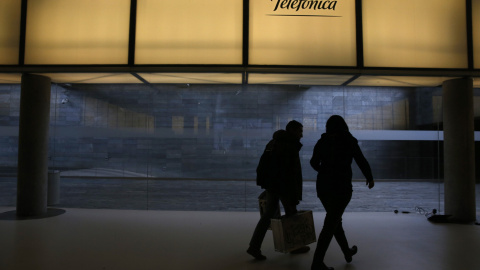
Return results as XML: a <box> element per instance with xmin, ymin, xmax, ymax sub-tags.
<box><xmin>0</xmin><ymin>0</ymin><xmax>480</xmax><ymax>215</ymax></box>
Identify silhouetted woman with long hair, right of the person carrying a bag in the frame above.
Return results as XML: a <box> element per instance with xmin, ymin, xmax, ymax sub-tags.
<box><xmin>310</xmin><ymin>115</ymin><xmax>374</xmax><ymax>270</ymax></box>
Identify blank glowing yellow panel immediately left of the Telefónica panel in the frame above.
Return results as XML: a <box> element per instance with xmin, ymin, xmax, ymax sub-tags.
<box><xmin>135</xmin><ymin>0</ymin><xmax>243</xmax><ymax>64</ymax></box>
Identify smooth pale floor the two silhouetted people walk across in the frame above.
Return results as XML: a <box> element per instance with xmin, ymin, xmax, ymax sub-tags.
<box><xmin>0</xmin><ymin>207</ymin><xmax>480</xmax><ymax>270</ymax></box>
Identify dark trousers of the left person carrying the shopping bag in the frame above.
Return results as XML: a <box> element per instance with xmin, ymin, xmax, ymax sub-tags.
<box><xmin>250</xmin><ymin>190</ymin><xmax>297</xmax><ymax>249</ymax></box>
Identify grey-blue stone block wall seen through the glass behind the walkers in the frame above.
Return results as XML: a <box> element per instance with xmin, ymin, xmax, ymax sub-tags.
<box><xmin>0</xmin><ymin>84</ymin><xmax>476</xmax><ymax>181</ymax></box>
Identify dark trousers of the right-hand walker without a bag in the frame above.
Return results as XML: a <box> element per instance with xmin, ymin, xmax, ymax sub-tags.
<box><xmin>312</xmin><ymin>192</ymin><xmax>352</xmax><ymax>270</ymax></box>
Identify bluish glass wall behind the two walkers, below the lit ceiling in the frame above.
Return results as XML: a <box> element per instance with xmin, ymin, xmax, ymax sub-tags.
<box><xmin>0</xmin><ymin>84</ymin><xmax>480</xmax><ymax>211</ymax></box>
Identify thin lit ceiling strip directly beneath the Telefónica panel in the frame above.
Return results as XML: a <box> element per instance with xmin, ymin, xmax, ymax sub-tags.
<box><xmin>248</xmin><ymin>73</ymin><xmax>352</xmax><ymax>85</ymax></box>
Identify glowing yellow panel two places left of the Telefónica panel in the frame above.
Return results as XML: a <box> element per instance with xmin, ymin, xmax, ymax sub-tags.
<box><xmin>25</xmin><ymin>0</ymin><xmax>130</xmax><ymax>64</ymax></box>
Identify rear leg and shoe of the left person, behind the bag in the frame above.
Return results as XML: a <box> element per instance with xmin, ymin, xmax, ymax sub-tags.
<box><xmin>247</xmin><ymin>191</ymin><xmax>279</xmax><ymax>259</ymax></box>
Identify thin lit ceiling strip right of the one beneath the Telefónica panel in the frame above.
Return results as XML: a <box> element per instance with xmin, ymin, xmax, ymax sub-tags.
<box><xmin>348</xmin><ymin>76</ymin><xmax>454</xmax><ymax>87</ymax></box>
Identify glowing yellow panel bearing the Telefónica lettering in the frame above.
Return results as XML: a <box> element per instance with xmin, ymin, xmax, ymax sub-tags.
<box><xmin>249</xmin><ymin>0</ymin><xmax>356</xmax><ymax>66</ymax></box>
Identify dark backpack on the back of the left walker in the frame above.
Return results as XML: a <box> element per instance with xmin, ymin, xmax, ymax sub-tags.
<box><xmin>257</xmin><ymin>139</ymin><xmax>277</xmax><ymax>189</ymax></box>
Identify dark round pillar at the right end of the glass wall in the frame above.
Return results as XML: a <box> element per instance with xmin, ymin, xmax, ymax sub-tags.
<box><xmin>443</xmin><ymin>78</ymin><xmax>476</xmax><ymax>222</ymax></box>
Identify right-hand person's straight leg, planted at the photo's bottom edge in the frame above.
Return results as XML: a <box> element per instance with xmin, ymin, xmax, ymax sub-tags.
<box><xmin>312</xmin><ymin>194</ymin><xmax>349</xmax><ymax>270</ymax></box>
